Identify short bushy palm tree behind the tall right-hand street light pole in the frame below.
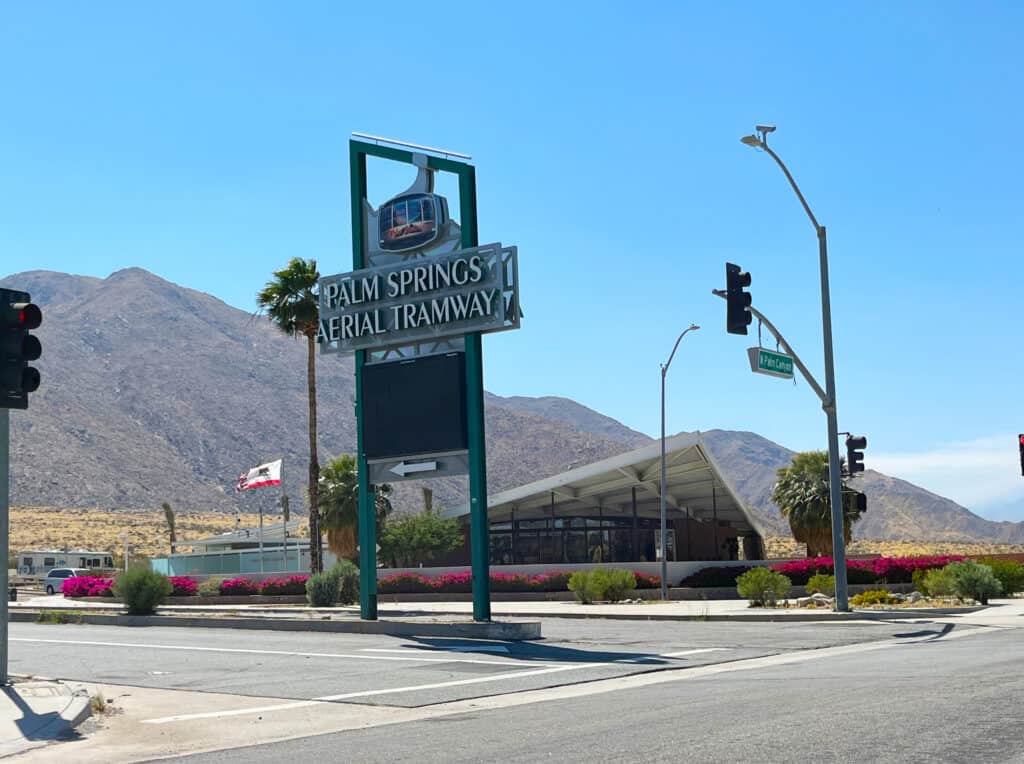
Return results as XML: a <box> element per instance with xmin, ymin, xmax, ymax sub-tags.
<box><xmin>771</xmin><ymin>451</ymin><xmax>861</xmax><ymax>557</ymax></box>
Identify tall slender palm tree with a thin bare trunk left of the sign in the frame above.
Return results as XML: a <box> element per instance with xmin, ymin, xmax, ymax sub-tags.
<box><xmin>256</xmin><ymin>257</ymin><xmax>324</xmax><ymax>572</ymax></box>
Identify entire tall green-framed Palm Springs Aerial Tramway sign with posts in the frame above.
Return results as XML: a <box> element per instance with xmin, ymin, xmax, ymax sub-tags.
<box><xmin>317</xmin><ymin>136</ymin><xmax>520</xmax><ymax>621</ymax></box>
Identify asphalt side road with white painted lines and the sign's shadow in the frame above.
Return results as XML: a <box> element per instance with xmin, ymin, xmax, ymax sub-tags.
<box><xmin>9</xmin><ymin>619</ymin><xmax>929</xmax><ymax>708</ymax></box>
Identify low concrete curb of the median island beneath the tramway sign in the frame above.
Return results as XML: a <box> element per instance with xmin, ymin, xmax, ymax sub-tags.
<box><xmin>10</xmin><ymin>610</ymin><xmax>541</xmax><ymax>641</ymax></box>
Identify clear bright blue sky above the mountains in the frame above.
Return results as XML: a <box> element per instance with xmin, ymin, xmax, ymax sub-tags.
<box><xmin>0</xmin><ymin>2</ymin><xmax>1024</xmax><ymax>519</ymax></box>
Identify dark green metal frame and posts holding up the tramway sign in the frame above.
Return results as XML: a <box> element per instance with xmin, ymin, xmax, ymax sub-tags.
<box><xmin>349</xmin><ymin>140</ymin><xmax>499</xmax><ymax>621</ymax></box>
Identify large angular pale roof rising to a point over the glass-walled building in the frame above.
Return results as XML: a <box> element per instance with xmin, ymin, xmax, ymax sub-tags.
<box><xmin>442</xmin><ymin>432</ymin><xmax>764</xmax><ymax>538</ymax></box>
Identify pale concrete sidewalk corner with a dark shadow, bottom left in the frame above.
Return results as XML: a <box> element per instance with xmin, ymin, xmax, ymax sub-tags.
<box><xmin>0</xmin><ymin>678</ymin><xmax>91</xmax><ymax>757</ymax></box>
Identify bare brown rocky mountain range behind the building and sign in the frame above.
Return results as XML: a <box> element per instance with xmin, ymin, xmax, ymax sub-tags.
<box><xmin>8</xmin><ymin>268</ymin><xmax>1024</xmax><ymax>543</ymax></box>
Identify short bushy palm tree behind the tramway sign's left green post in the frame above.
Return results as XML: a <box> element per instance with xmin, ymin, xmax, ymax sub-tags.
<box><xmin>319</xmin><ymin>454</ymin><xmax>391</xmax><ymax>560</ymax></box>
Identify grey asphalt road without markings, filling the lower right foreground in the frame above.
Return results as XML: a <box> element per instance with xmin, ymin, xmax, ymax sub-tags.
<box><xmin>172</xmin><ymin>624</ymin><xmax>1024</xmax><ymax>764</ymax></box>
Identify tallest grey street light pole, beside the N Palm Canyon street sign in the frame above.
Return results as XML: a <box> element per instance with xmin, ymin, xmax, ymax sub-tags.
<box><xmin>740</xmin><ymin>125</ymin><xmax>850</xmax><ymax>612</ymax></box>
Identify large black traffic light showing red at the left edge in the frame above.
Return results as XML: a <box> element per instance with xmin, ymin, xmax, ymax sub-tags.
<box><xmin>0</xmin><ymin>289</ymin><xmax>43</xmax><ymax>409</ymax></box>
